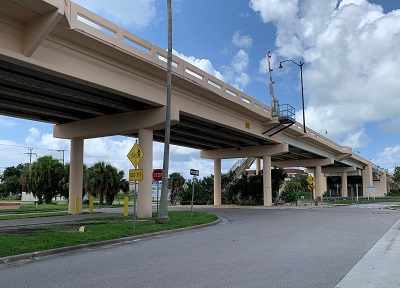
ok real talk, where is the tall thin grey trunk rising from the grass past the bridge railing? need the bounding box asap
[157,0,172,223]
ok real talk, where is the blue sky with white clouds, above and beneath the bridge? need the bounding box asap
[0,0,400,179]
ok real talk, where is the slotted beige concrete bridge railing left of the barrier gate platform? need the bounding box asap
[64,0,271,119]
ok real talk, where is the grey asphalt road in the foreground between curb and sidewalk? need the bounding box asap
[0,207,400,288]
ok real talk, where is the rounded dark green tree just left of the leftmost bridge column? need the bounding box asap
[22,156,65,204]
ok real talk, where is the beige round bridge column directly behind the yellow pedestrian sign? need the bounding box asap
[137,129,153,218]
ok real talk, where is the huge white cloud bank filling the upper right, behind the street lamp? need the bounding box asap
[250,0,400,140]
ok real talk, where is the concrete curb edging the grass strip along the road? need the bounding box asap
[0,217,223,269]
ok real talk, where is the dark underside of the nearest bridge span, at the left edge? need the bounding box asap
[0,61,153,124]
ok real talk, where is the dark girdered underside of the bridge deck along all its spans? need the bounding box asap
[0,61,354,166]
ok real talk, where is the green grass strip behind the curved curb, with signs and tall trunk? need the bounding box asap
[0,211,218,257]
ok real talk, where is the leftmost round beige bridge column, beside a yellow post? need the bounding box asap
[68,138,84,214]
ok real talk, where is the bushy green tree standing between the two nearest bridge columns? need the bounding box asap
[84,161,124,205]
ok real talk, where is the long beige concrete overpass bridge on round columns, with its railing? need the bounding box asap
[0,0,387,217]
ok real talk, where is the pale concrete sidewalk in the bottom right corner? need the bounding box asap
[335,219,400,288]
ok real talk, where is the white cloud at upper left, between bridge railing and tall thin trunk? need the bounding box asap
[74,0,157,28]
